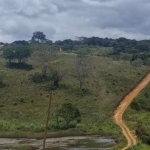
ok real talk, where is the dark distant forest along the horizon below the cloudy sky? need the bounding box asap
[0,35,150,65]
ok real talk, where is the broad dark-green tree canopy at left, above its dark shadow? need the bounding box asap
[2,46,32,63]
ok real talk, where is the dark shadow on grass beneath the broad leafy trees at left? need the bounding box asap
[6,62,33,71]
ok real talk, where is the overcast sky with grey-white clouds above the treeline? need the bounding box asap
[0,0,150,43]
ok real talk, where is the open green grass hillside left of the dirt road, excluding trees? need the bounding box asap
[0,45,149,148]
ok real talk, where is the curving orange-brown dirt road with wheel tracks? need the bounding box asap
[113,72,150,150]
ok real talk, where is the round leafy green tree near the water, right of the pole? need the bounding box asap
[59,103,81,127]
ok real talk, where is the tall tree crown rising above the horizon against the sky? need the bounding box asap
[31,31,46,43]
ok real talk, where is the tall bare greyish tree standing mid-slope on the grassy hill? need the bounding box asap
[75,51,89,90]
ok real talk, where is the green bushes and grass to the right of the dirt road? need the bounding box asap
[125,84,150,150]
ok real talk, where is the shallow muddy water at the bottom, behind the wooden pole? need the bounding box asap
[0,136,116,150]
